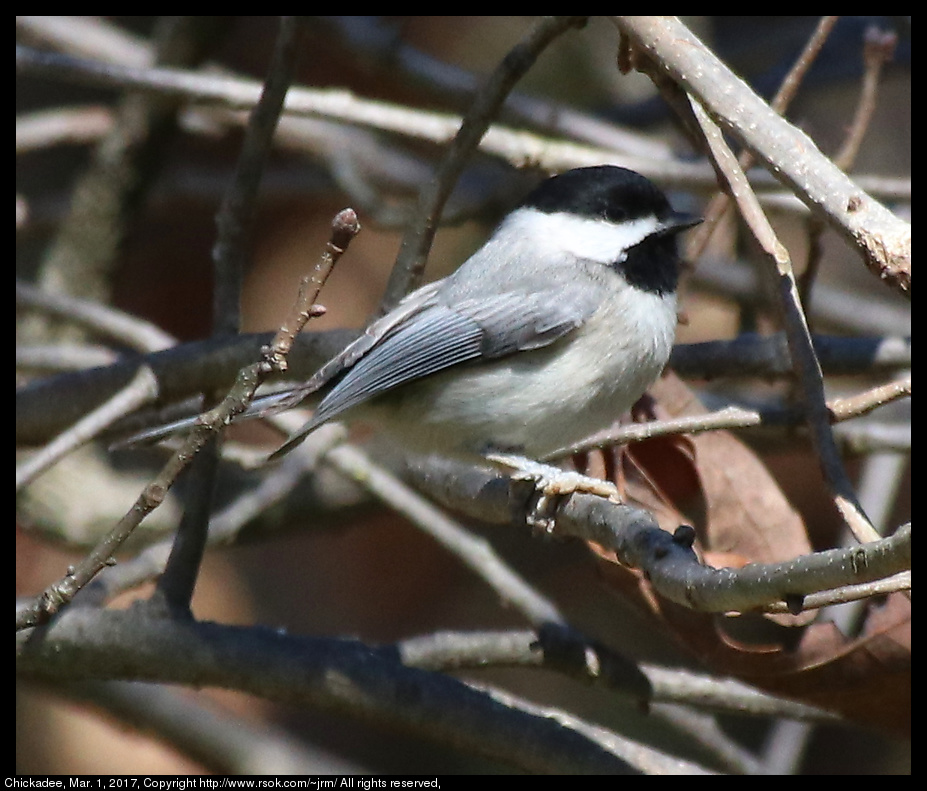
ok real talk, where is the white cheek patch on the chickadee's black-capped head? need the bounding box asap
[506,208,662,264]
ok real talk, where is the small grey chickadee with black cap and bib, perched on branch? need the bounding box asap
[141,165,700,474]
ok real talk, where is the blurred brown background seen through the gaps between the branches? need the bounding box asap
[16,16,911,774]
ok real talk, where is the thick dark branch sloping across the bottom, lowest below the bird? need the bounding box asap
[17,608,644,774]
